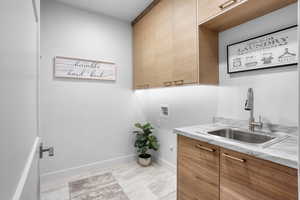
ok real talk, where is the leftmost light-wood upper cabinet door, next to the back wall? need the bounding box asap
[133,0,173,89]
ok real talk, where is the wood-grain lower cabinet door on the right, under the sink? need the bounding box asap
[220,149,298,200]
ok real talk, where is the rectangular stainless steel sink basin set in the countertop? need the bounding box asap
[208,128,276,144]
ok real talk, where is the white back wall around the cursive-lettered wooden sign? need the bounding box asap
[40,0,144,174]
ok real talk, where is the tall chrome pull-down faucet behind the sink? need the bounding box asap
[245,88,263,132]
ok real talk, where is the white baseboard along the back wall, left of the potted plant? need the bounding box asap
[41,154,135,183]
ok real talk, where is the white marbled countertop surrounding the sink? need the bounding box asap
[174,123,298,169]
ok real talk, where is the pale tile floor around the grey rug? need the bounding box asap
[41,162,176,200]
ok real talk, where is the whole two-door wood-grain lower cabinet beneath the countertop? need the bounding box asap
[177,136,298,200]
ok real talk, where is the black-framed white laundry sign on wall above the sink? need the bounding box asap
[227,25,298,74]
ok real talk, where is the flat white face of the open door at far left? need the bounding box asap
[0,0,37,200]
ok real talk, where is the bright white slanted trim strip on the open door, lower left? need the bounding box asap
[12,137,40,200]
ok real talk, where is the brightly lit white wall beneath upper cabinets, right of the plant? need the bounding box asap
[136,85,218,165]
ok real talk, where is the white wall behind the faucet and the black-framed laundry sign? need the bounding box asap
[217,3,298,126]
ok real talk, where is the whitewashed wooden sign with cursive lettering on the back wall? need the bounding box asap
[54,56,117,81]
